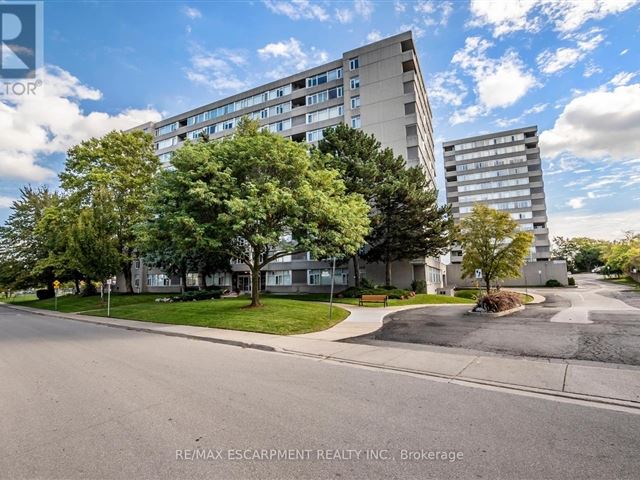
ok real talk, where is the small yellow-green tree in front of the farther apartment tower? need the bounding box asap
[459,204,533,293]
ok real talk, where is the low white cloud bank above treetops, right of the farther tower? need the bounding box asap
[549,209,640,240]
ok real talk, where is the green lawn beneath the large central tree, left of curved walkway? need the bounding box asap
[10,294,349,335]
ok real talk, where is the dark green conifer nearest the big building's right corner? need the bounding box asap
[365,149,454,285]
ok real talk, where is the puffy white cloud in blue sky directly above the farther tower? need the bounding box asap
[451,37,538,124]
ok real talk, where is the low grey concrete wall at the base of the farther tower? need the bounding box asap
[447,260,568,287]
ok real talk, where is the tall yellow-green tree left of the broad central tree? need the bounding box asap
[60,131,159,293]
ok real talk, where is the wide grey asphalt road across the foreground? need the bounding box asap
[0,306,640,479]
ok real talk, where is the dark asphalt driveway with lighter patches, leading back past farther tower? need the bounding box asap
[352,274,640,365]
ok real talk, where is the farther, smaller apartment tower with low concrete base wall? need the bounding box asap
[443,126,567,286]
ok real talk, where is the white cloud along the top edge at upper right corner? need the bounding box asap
[469,0,639,37]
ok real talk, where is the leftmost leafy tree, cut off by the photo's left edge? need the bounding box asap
[0,186,60,290]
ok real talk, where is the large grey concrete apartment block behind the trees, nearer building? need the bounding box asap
[124,32,443,292]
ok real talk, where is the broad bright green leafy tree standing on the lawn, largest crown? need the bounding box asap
[162,119,369,307]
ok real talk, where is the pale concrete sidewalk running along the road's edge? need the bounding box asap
[8,305,640,410]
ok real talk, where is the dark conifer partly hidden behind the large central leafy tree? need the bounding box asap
[318,123,382,287]
